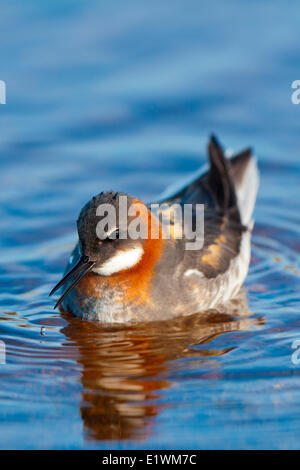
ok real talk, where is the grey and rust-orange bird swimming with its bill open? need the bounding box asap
[49,135,259,324]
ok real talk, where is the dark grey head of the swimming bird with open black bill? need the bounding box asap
[50,192,159,307]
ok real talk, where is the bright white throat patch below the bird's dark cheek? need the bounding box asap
[93,246,144,276]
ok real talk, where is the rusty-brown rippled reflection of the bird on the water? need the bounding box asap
[62,295,262,441]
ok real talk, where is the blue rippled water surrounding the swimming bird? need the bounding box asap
[0,0,300,449]
